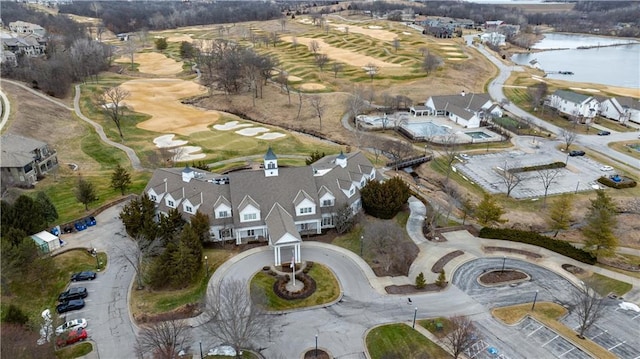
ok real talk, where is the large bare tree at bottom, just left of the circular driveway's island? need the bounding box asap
[203,279,272,358]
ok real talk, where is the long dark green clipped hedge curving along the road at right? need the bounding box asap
[479,227,597,264]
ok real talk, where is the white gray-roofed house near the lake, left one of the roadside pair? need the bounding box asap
[547,90,600,124]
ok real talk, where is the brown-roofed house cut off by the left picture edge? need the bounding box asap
[0,134,58,187]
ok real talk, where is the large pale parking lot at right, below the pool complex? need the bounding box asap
[454,137,615,199]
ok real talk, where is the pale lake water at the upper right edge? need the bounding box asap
[511,33,640,88]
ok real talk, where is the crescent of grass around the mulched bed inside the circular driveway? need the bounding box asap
[251,263,340,310]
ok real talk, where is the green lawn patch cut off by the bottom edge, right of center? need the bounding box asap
[366,324,452,359]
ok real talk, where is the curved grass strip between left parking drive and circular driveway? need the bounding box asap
[130,249,234,318]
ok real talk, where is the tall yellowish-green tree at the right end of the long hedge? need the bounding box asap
[582,190,618,257]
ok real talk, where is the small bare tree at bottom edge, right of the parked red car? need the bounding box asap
[136,320,191,359]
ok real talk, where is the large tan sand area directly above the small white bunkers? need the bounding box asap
[120,79,220,136]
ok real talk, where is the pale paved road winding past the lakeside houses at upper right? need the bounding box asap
[465,37,640,170]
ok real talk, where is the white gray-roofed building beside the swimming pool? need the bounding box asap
[425,91,503,128]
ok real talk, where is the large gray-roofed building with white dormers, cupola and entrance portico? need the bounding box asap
[144,148,378,265]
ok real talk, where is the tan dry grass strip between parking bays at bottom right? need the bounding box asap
[491,302,616,359]
